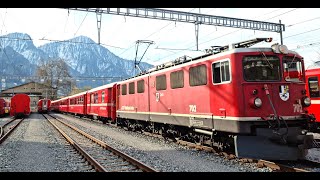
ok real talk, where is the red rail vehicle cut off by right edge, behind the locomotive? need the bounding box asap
[306,67,320,132]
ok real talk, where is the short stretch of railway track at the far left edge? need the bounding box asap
[0,118,24,144]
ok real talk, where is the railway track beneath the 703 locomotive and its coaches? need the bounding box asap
[55,113,320,172]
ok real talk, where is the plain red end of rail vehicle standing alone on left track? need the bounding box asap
[10,94,30,118]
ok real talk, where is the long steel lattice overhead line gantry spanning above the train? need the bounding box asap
[64,8,285,47]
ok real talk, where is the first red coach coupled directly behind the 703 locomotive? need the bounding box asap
[87,83,117,123]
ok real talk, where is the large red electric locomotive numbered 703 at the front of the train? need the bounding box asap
[116,38,313,160]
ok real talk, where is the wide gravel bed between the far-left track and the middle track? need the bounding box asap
[0,113,92,172]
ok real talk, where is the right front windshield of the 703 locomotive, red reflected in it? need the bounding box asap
[283,56,303,82]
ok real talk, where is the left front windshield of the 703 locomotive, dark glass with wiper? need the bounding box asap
[243,55,280,81]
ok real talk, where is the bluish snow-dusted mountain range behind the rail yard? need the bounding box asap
[0,32,153,88]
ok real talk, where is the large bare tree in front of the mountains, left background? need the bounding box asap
[36,58,76,99]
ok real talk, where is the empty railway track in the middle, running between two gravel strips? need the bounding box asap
[43,114,157,172]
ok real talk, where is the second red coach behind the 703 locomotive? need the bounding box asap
[68,92,87,116]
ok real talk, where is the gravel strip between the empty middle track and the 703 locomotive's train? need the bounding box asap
[56,114,270,172]
